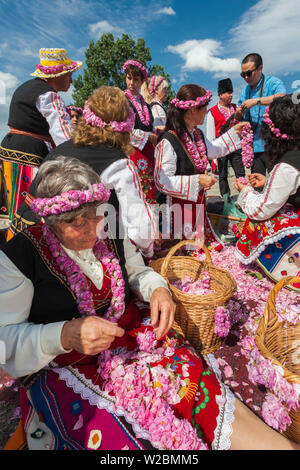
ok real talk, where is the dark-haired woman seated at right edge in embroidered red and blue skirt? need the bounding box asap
[235,95,300,290]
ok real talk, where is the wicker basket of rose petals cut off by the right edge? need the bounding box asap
[255,276,300,443]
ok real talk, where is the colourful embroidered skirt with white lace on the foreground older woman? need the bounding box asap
[21,306,235,450]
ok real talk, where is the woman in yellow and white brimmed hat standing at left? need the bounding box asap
[0,48,82,237]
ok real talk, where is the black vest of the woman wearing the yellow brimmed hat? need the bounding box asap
[8,78,55,135]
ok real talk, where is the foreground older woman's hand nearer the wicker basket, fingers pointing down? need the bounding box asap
[150,287,176,339]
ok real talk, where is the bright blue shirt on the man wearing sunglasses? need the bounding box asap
[238,76,286,152]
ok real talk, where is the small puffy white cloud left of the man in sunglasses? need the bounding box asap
[167,39,240,76]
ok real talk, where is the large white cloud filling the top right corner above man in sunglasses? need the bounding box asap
[228,0,300,74]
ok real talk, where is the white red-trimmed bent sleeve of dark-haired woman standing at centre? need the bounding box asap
[154,139,200,201]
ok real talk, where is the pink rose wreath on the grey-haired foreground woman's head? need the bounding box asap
[30,183,110,217]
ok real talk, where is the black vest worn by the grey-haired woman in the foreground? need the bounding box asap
[2,227,129,324]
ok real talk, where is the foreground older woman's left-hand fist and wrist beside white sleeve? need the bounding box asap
[61,316,125,356]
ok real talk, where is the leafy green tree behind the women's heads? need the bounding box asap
[72,33,175,107]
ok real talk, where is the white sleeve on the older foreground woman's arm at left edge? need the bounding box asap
[0,251,67,377]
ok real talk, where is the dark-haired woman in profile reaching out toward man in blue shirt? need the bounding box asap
[154,84,245,249]
